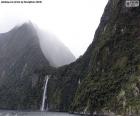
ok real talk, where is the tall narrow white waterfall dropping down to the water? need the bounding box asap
[40,75,49,111]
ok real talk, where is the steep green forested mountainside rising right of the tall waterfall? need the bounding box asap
[47,0,140,115]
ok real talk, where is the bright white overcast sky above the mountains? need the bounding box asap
[0,0,108,57]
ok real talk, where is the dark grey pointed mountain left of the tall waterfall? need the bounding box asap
[0,24,49,109]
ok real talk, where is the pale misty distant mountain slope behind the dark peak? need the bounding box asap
[37,29,76,67]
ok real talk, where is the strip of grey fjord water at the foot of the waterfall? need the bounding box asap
[0,111,78,116]
